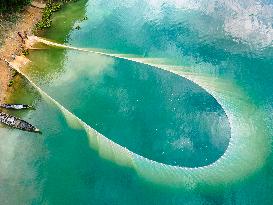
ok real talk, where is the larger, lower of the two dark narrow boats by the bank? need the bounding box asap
[0,112,41,133]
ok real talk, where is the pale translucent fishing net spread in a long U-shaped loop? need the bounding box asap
[9,36,270,189]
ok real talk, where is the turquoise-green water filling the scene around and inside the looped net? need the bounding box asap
[0,0,273,204]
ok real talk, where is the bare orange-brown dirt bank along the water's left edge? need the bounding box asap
[0,4,43,103]
